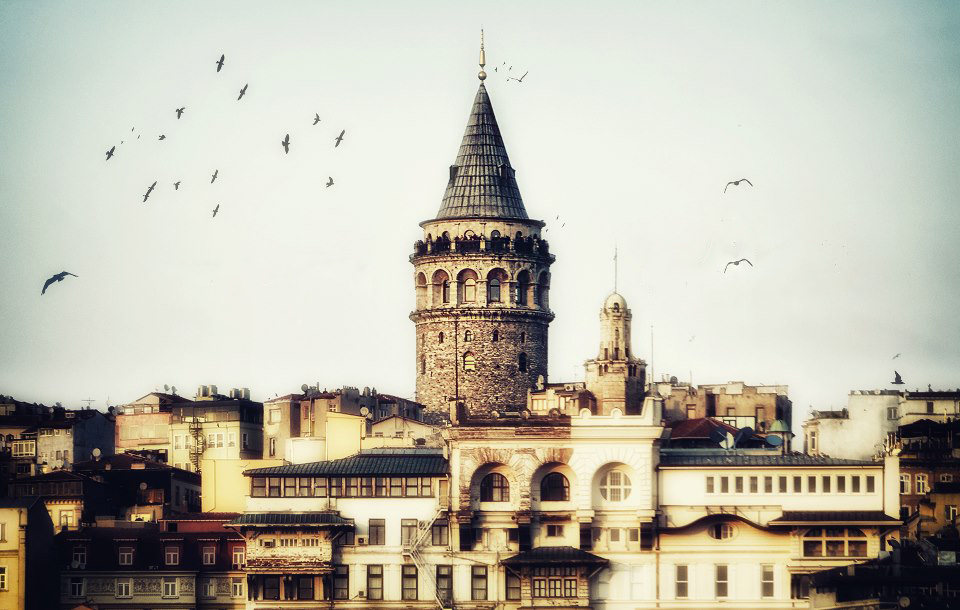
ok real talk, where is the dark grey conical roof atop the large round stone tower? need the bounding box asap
[437,83,527,219]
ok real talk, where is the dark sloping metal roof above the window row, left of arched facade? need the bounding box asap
[244,450,449,477]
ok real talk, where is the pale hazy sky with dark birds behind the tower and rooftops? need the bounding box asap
[0,0,960,431]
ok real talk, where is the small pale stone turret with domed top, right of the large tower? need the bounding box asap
[584,292,647,415]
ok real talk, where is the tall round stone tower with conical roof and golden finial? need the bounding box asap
[410,48,554,417]
